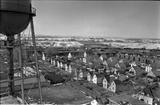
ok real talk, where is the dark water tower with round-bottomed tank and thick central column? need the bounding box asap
[0,0,42,102]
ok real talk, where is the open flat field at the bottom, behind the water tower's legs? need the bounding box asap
[26,85,92,104]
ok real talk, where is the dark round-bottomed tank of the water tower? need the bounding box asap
[0,0,33,36]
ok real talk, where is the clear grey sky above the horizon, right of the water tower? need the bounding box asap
[32,0,160,38]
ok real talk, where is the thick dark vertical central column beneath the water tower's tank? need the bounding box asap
[7,35,14,96]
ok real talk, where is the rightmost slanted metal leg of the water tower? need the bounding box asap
[31,17,42,104]
